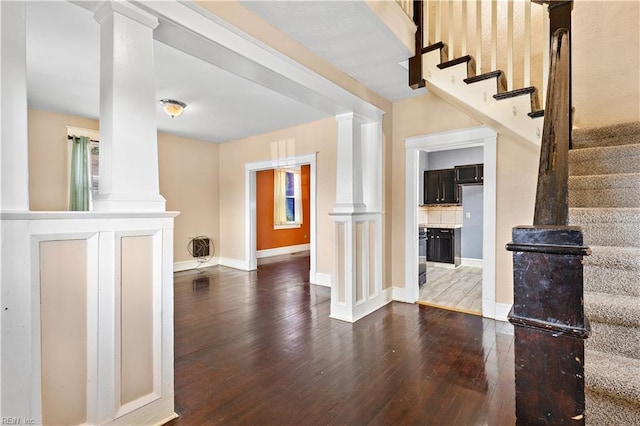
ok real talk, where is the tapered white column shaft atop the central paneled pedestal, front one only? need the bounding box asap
[333,112,365,213]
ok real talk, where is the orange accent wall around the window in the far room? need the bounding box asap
[256,165,311,250]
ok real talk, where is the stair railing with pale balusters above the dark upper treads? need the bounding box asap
[410,0,550,107]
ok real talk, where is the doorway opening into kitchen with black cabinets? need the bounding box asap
[417,146,484,315]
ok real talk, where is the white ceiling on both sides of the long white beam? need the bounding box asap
[27,1,415,142]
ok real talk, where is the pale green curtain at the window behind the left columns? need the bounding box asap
[69,136,91,211]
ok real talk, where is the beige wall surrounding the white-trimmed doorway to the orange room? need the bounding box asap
[220,117,337,273]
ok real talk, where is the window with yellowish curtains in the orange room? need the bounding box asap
[273,169,302,229]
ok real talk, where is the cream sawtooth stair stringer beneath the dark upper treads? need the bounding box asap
[422,49,544,146]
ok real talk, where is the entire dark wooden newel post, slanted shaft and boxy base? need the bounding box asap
[507,1,589,425]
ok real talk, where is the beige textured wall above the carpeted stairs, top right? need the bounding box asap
[571,0,640,127]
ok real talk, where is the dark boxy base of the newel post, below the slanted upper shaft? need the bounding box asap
[507,226,589,425]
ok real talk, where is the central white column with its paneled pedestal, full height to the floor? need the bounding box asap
[331,113,384,322]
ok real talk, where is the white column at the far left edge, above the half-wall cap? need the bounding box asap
[0,1,29,211]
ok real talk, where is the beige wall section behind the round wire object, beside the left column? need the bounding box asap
[158,133,220,262]
